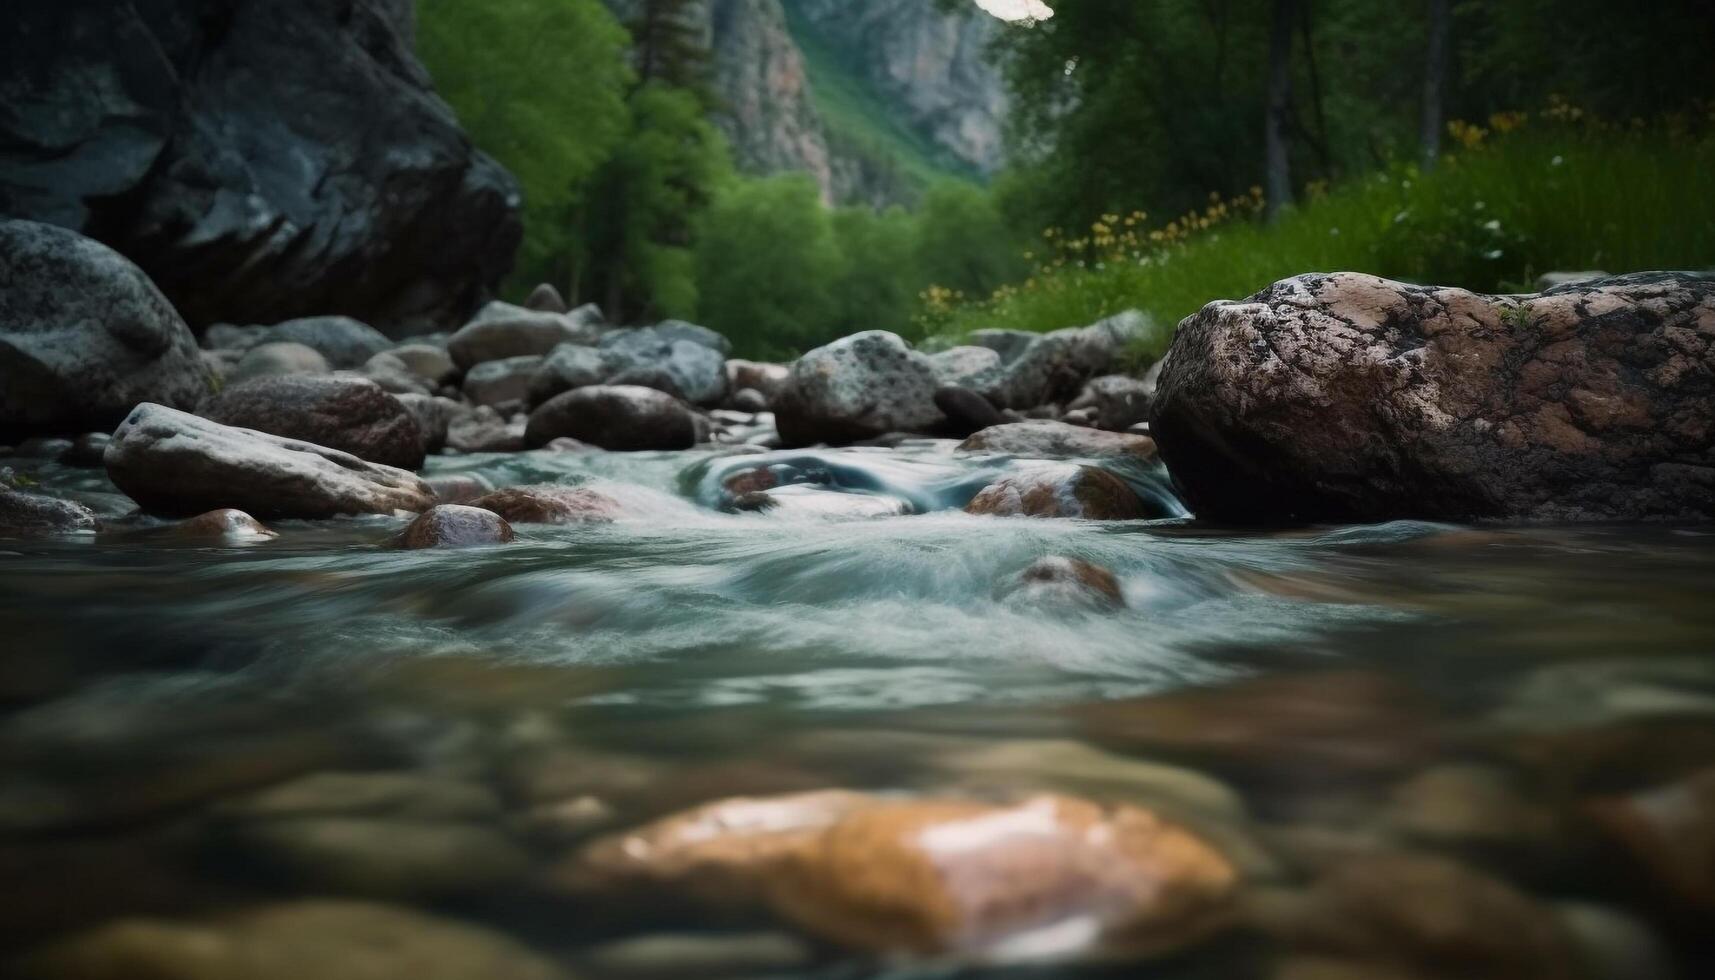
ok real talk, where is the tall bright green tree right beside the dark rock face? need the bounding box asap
[417,0,635,285]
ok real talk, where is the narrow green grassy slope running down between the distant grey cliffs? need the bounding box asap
[784,3,974,196]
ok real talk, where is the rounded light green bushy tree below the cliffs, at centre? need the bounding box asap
[695,173,840,357]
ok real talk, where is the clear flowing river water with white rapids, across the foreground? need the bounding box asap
[0,441,1715,978]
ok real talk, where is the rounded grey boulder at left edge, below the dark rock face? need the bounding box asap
[0,224,211,438]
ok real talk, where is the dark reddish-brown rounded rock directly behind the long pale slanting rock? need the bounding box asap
[197,374,424,470]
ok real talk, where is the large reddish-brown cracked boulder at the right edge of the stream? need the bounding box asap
[1151,273,1715,522]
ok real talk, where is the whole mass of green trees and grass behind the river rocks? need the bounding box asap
[418,0,1715,359]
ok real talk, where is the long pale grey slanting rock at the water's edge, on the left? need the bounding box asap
[106,403,434,517]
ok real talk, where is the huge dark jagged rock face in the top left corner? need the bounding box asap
[0,0,520,335]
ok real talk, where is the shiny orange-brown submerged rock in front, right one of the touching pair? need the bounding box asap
[770,796,1238,961]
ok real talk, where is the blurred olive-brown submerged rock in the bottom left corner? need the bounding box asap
[14,898,561,980]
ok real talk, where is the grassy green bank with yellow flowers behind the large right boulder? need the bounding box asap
[924,129,1715,360]
